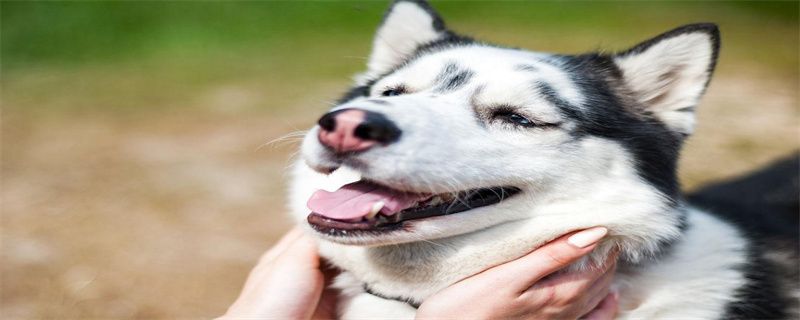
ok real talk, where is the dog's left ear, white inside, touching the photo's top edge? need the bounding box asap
[367,0,447,76]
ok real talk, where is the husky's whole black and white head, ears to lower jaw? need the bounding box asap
[294,1,718,245]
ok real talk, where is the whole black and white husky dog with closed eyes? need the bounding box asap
[291,1,796,319]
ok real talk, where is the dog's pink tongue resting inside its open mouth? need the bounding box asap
[307,182,427,220]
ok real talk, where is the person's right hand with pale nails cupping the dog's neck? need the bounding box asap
[417,227,618,320]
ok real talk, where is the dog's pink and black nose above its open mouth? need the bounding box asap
[317,108,402,144]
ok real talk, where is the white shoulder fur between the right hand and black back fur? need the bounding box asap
[616,210,747,319]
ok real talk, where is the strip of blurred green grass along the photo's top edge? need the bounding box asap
[2,1,798,69]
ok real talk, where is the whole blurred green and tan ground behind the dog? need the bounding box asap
[0,1,800,319]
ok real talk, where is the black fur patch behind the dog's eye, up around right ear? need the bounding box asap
[539,23,720,203]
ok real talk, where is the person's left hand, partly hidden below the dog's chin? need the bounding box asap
[219,227,336,319]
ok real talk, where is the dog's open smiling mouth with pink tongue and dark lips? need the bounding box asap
[308,181,520,236]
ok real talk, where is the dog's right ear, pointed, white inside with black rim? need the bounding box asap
[614,23,719,135]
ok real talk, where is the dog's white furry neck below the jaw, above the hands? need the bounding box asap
[324,195,686,302]
